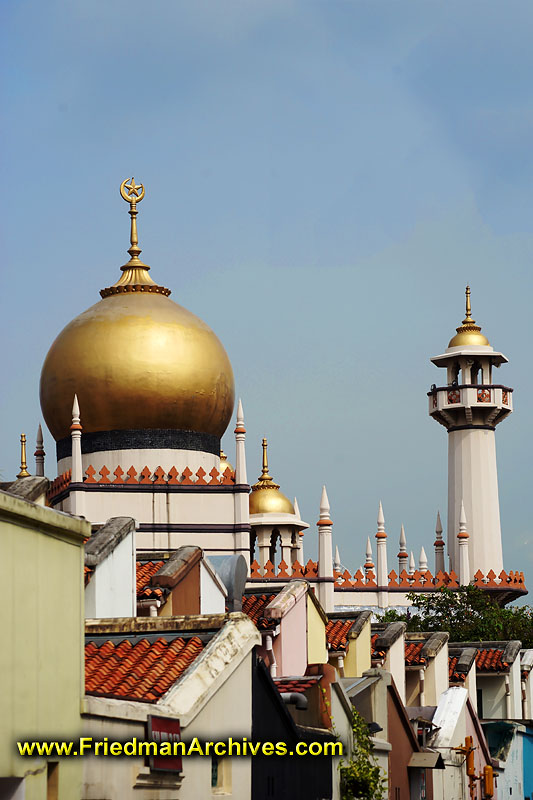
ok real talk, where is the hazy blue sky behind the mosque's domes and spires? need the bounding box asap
[0,0,533,587]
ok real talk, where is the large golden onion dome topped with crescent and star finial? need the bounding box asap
[40,179,235,440]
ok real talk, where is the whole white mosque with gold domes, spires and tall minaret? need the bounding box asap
[35,178,526,612]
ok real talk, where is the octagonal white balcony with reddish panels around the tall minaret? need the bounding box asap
[428,383,513,428]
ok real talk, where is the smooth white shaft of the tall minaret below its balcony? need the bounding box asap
[448,429,503,575]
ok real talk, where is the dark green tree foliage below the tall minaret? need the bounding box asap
[381,586,533,647]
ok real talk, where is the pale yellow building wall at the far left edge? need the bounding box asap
[0,492,90,800]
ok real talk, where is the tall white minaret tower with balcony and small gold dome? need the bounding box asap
[428,286,513,577]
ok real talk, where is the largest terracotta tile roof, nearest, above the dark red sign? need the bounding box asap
[85,636,204,703]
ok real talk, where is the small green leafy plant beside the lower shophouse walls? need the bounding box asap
[339,708,386,800]
